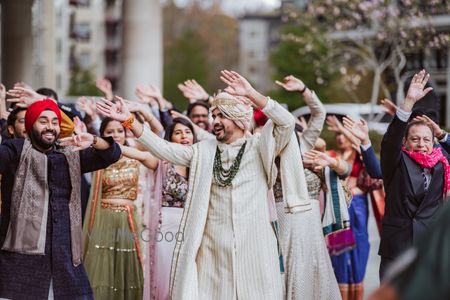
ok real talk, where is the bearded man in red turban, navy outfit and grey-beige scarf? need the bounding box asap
[0,99,121,299]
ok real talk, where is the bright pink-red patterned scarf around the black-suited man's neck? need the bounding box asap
[402,147,450,197]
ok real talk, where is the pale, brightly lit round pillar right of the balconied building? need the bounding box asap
[119,0,163,98]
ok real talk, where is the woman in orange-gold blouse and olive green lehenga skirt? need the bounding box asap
[83,118,143,300]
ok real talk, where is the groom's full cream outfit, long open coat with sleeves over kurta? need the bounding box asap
[139,101,295,300]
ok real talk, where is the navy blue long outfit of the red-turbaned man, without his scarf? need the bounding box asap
[0,139,121,299]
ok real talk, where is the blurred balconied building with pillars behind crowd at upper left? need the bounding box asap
[0,0,162,97]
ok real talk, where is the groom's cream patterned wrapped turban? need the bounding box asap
[209,92,253,131]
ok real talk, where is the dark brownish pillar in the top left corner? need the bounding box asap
[2,0,33,88]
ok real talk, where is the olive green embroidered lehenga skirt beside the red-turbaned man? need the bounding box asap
[84,204,143,300]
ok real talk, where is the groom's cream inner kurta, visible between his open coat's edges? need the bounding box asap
[197,137,281,299]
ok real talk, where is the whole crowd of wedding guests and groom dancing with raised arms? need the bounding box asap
[0,70,450,300]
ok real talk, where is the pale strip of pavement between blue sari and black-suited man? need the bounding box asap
[364,199,380,299]
